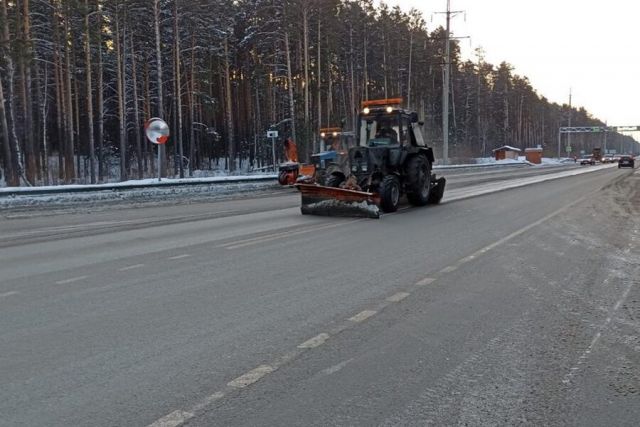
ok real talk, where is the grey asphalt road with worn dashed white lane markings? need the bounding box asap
[0,168,640,426]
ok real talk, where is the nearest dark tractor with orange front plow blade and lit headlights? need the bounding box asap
[296,98,446,218]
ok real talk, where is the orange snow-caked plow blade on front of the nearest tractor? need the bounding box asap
[296,184,380,219]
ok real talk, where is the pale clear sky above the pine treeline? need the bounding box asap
[386,0,640,126]
